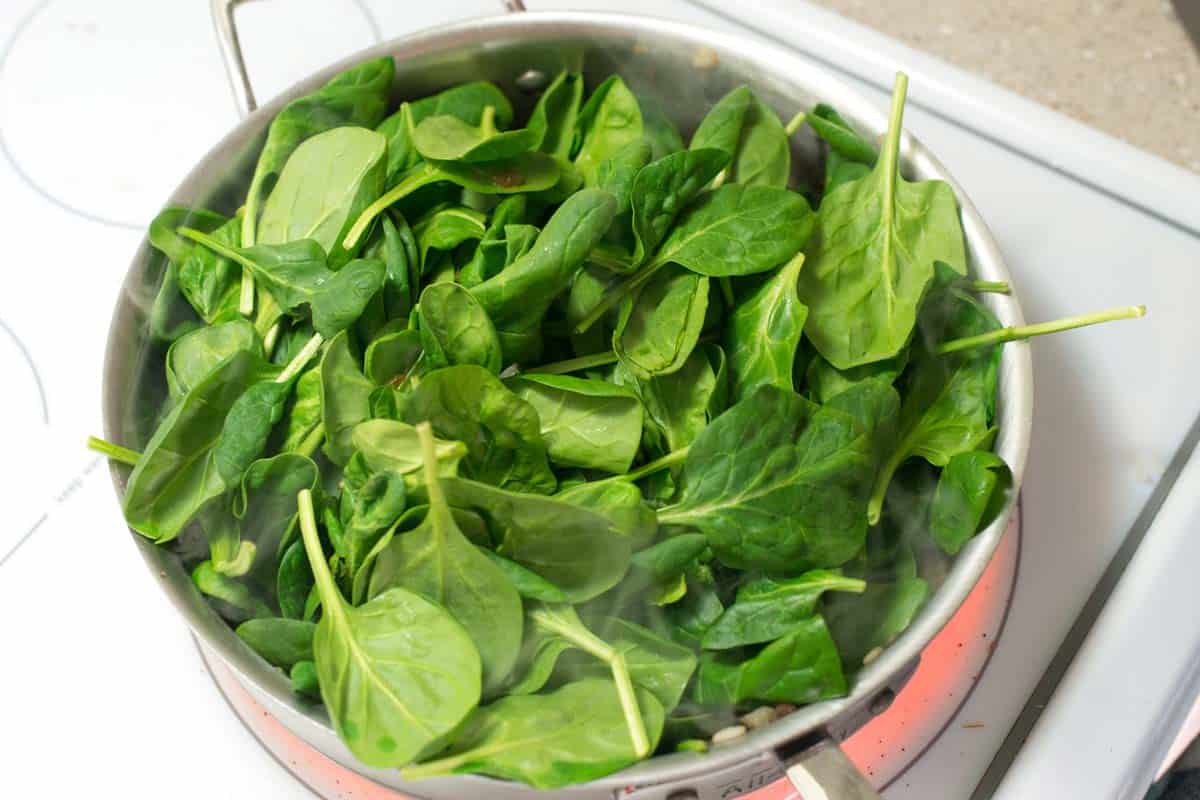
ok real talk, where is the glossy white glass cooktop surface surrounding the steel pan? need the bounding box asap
[0,0,1200,800]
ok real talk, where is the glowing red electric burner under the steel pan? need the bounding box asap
[199,504,1021,800]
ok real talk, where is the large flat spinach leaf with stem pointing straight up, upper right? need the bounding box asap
[799,74,966,369]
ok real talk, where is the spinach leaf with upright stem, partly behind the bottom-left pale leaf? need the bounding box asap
[368,423,522,694]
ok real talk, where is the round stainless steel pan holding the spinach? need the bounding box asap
[104,0,1033,800]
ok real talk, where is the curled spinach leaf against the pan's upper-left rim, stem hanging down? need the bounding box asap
[241,58,396,246]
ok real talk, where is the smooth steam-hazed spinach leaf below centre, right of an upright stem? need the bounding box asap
[442,477,632,603]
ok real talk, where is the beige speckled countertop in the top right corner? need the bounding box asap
[816,0,1200,172]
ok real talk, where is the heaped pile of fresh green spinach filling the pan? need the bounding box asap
[92,59,1140,788]
